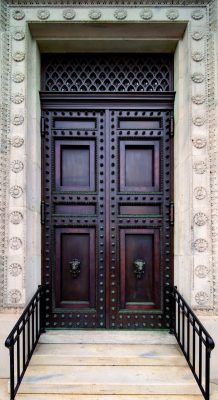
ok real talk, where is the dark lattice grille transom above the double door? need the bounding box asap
[42,54,173,92]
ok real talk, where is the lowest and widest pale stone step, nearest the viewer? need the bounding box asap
[19,365,200,399]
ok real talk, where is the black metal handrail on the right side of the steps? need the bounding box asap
[171,287,215,400]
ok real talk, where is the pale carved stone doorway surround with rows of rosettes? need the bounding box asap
[0,0,218,377]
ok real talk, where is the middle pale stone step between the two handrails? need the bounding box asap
[31,343,187,366]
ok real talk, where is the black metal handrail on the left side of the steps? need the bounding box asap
[5,286,45,400]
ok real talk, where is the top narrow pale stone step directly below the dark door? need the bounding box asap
[39,330,177,344]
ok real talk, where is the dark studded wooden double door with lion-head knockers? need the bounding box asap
[41,93,173,329]
